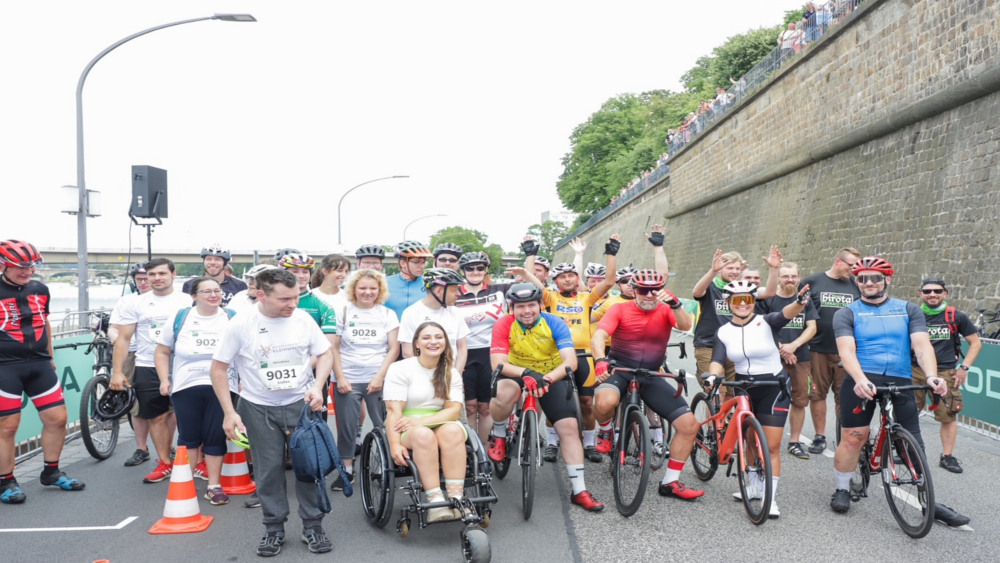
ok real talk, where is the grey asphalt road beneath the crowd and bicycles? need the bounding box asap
[0,332,1000,563]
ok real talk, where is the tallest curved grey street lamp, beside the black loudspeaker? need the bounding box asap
[76,14,257,311]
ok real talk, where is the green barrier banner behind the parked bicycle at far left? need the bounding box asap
[14,334,94,443]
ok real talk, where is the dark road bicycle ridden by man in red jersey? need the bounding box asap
[608,363,687,517]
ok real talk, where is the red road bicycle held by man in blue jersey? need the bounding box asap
[850,385,948,538]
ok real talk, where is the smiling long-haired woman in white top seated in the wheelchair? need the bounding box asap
[382,322,468,522]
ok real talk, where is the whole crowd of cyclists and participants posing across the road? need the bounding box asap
[0,230,981,556]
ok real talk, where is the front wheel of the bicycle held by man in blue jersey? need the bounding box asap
[881,427,934,538]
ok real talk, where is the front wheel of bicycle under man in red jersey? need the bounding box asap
[610,408,649,517]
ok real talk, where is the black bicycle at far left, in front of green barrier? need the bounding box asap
[53,313,122,460]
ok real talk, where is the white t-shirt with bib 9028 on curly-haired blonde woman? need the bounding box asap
[337,303,399,383]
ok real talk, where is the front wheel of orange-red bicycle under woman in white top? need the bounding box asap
[737,416,774,526]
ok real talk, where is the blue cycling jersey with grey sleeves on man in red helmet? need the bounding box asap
[833,298,927,379]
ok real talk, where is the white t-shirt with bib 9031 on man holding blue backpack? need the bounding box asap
[212,309,330,406]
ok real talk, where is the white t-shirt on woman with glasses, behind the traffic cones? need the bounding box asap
[157,308,232,393]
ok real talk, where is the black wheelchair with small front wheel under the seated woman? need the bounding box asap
[360,425,497,563]
